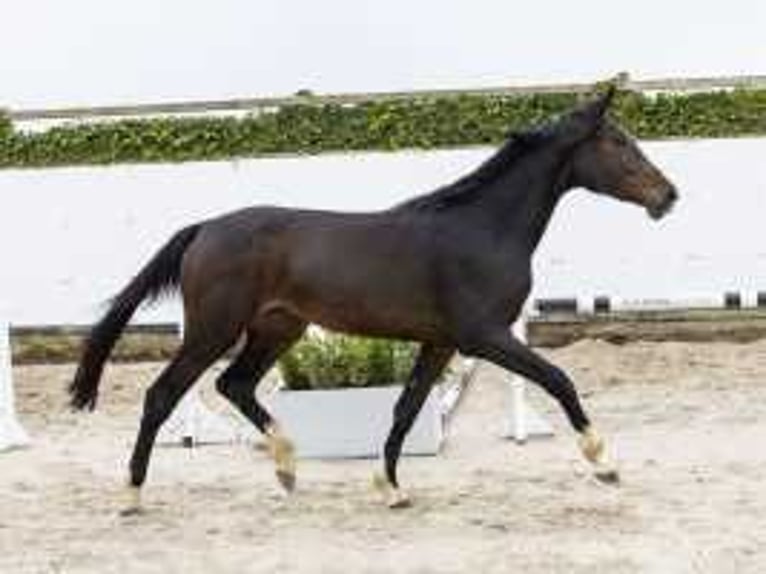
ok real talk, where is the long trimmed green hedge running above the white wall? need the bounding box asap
[0,90,766,168]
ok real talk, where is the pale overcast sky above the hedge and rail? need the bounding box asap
[0,0,766,109]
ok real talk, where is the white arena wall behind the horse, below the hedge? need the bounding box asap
[0,138,766,324]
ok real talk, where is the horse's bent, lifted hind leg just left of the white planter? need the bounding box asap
[216,315,306,492]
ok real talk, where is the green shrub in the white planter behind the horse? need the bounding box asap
[278,334,417,390]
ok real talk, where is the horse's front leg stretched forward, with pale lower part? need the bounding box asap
[458,326,619,483]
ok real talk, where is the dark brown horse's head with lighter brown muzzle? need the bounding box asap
[562,90,678,219]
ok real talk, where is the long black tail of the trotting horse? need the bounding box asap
[69,225,200,410]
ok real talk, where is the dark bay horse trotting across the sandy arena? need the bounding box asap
[70,90,677,510]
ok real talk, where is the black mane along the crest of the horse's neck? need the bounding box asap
[394,126,553,214]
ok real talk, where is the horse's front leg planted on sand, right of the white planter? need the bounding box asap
[374,344,455,508]
